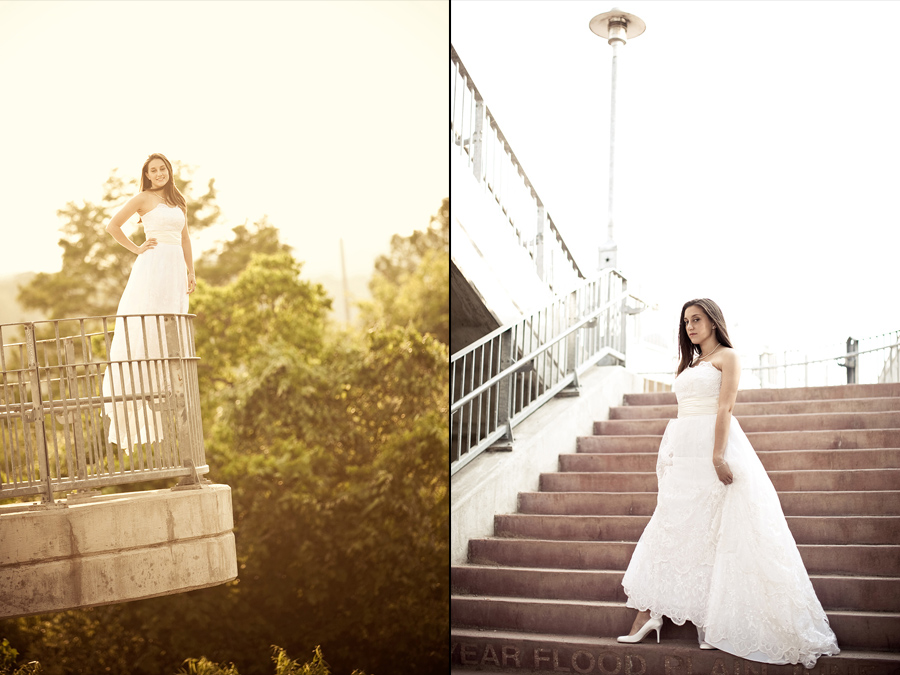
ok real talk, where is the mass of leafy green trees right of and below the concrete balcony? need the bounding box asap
[0,184,449,675]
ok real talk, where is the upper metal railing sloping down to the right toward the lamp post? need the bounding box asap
[450,45,585,289]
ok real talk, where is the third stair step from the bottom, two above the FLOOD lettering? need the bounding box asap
[450,565,900,612]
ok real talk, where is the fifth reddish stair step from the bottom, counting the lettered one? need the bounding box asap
[494,513,900,544]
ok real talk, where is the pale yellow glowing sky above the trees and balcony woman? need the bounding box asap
[0,0,449,276]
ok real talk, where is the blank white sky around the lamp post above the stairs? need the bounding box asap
[450,0,900,350]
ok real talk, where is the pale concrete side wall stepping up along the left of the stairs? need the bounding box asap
[450,366,644,565]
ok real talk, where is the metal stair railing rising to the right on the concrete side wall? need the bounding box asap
[450,270,630,475]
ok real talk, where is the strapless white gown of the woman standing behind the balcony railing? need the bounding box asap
[103,204,188,452]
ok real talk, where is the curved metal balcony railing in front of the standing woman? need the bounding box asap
[0,314,209,504]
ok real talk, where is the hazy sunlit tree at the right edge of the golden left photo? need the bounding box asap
[360,198,450,344]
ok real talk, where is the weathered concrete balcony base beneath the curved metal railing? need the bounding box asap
[0,485,237,617]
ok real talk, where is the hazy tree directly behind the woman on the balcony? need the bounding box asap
[18,165,221,319]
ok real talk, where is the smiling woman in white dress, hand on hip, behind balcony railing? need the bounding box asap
[102,153,196,452]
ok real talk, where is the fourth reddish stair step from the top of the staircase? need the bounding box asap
[575,429,900,452]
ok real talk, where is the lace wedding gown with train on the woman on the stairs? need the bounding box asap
[622,361,839,668]
